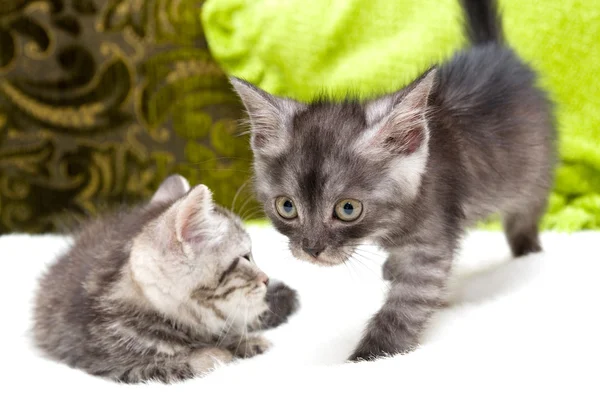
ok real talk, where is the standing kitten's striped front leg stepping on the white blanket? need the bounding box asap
[350,245,452,361]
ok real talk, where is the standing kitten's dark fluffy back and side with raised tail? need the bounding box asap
[430,0,556,224]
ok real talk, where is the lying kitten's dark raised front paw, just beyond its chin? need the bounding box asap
[260,282,300,329]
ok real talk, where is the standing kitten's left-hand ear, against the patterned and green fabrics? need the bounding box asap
[230,77,305,155]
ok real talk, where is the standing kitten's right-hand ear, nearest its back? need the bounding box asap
[366,69,436,155]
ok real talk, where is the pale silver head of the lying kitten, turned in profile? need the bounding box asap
[130,176,268,334]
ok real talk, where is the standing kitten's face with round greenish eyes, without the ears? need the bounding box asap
[256,104,396,265]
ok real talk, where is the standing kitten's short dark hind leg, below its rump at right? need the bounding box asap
[503,202,545,257]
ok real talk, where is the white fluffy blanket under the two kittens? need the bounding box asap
[0,227,600,398]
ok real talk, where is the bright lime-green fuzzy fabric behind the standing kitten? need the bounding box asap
[202,0,600,231]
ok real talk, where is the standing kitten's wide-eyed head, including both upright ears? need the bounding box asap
[231,70,435,265]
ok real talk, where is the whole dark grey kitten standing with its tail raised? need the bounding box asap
[232,0,556,360]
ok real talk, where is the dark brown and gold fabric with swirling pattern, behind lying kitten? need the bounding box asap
[0,0,255,233]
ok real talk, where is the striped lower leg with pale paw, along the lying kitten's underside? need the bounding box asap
[111,347,233,384]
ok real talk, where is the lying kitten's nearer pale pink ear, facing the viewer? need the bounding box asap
[175,184,213,243]
